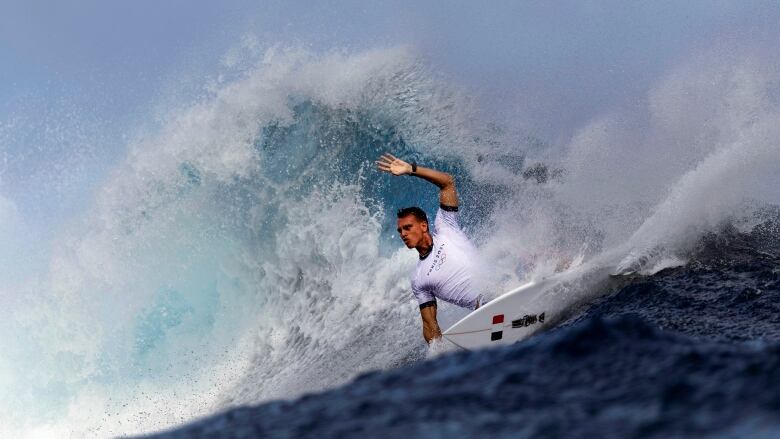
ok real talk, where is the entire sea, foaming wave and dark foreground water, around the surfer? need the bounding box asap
[0,48,780,437]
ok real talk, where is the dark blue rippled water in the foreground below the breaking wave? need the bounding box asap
[146,222,780,438]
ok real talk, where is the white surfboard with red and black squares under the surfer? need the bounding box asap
[442,269,609,349]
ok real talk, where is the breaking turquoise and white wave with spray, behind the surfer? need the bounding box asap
[0,43,780,437]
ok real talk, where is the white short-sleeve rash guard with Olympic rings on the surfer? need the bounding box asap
[412,205,482,309]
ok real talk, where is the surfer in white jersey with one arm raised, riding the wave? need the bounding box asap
[376,153,483,343]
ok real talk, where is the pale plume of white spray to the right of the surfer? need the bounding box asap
[483,45,780,285]
